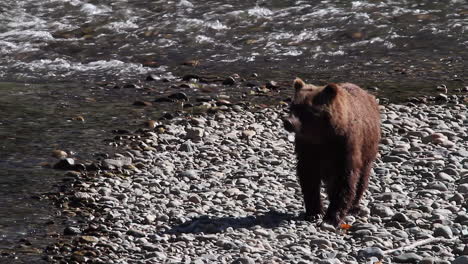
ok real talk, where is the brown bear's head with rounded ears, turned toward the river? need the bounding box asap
[283,78,340,143]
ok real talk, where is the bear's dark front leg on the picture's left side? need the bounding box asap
[297,160,323,221]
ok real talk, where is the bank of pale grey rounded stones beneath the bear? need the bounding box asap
[46,100,468,264]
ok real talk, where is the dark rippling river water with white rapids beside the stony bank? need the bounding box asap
[0,0,468,261]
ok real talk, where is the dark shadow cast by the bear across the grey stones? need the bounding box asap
[164,211,304,234]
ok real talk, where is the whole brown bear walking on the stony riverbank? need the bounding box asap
[284,78,380,226]
